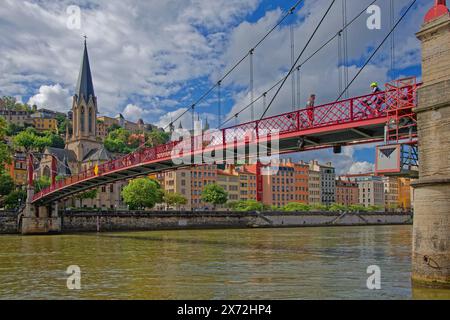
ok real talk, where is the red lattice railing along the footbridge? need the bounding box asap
[34,86,416,201]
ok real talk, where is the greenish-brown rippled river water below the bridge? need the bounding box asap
[0,226,450,299]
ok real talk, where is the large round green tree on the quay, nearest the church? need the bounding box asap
[122,178,164,210]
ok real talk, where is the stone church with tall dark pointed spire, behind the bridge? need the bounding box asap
[38,41,127,210]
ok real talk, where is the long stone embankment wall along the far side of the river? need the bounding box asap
[0,211,412,234]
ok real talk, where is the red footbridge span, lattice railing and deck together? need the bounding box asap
[33,80,417,204]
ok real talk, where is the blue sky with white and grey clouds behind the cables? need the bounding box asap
[0,0,433,172]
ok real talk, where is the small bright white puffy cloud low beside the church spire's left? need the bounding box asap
[28,84,71,112]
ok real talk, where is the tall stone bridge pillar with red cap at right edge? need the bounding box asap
[412,0,450,288]
